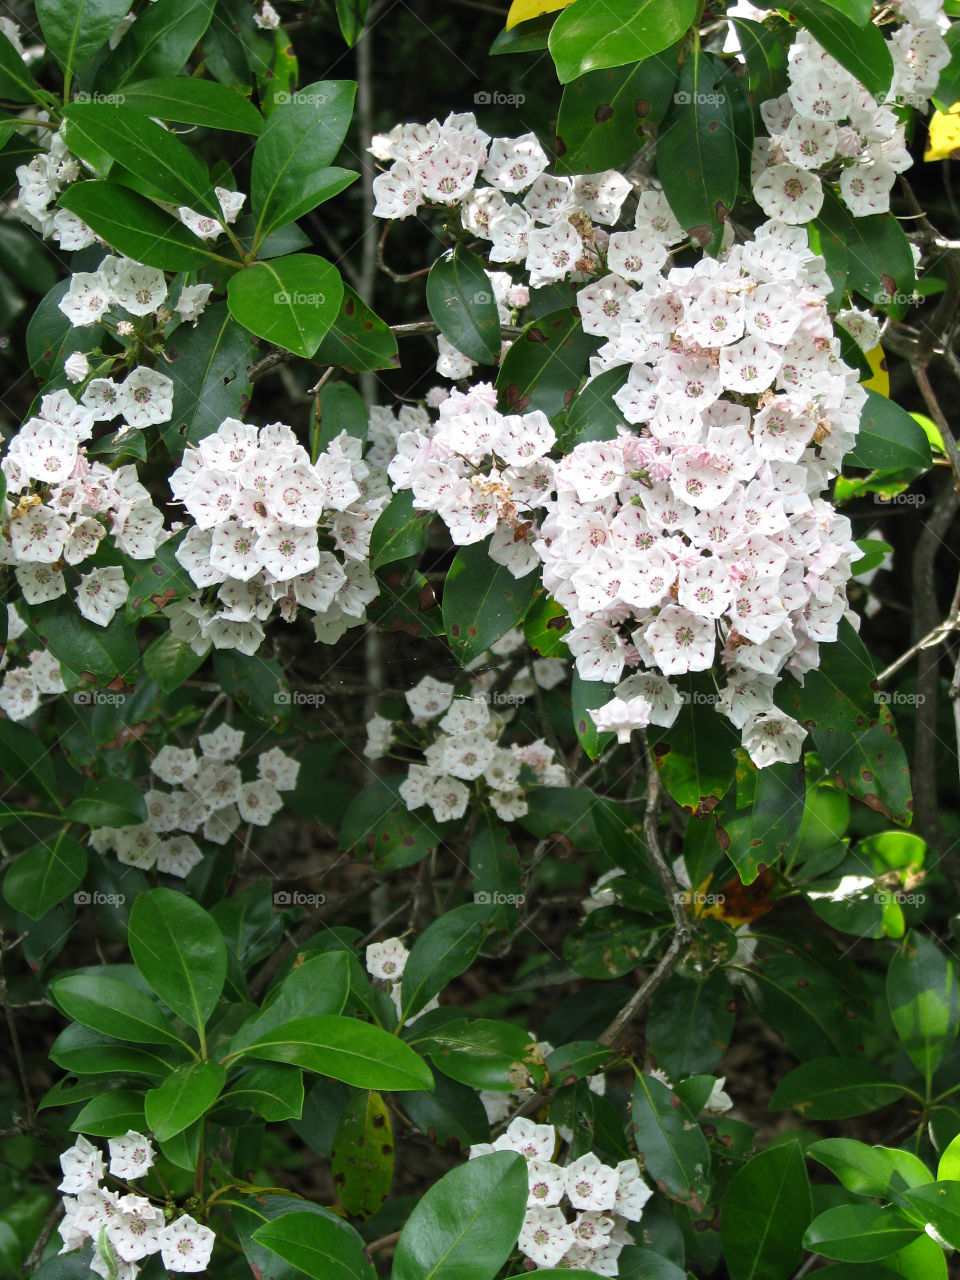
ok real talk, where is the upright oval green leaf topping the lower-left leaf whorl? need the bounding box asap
[128,888,227,1039]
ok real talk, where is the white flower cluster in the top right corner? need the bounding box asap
[753,0,950,224]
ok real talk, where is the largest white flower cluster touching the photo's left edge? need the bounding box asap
[0,384,164,626]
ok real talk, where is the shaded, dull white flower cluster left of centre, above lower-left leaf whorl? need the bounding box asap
[90,724,300,877]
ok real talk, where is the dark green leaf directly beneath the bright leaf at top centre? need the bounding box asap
[557,47,677,174]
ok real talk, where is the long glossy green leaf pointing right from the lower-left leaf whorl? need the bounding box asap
[239,1014,433,1091]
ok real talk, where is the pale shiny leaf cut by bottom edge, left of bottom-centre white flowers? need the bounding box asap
[393,1151,527,1280]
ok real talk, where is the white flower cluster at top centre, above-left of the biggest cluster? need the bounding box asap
[370,113,631,286]
